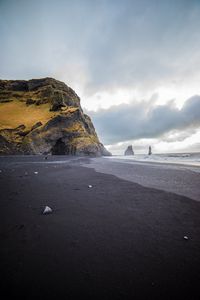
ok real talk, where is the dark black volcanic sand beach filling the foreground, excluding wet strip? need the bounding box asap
[0,157,200,300]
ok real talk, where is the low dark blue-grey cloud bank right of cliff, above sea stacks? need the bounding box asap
[87,95,200,144]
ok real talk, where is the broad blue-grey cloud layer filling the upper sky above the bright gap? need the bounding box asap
[0,0,200,96]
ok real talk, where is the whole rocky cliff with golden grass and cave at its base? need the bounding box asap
[0,78,110,156]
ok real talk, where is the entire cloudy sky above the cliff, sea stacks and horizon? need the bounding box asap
[0,0,200,153]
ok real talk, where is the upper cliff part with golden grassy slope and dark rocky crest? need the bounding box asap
[0,77,81,129]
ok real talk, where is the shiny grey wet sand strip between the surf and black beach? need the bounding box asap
[83,157,200,201]
